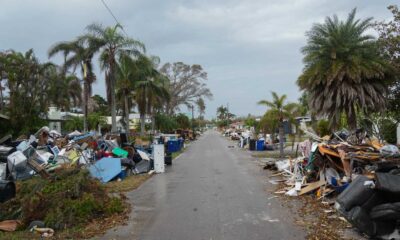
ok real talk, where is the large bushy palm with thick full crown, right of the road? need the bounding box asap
[297,9,388,129]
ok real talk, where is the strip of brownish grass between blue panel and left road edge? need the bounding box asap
[106,173,152,193]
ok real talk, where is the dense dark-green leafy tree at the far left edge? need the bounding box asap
[3,49,56,134]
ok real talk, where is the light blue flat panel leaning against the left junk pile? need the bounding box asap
[89,158,121,183]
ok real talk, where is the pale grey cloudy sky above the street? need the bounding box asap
[0,0,398,118]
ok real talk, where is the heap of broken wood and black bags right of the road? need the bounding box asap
[265,129,400,239]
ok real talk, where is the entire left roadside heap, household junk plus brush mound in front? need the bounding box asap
[0,127,164,237]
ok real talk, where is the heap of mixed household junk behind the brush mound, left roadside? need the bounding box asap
[0,127,159,202]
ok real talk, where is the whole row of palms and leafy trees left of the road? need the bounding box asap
[0,24,212,135]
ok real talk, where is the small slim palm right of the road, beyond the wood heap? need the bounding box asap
[258,92,297,157]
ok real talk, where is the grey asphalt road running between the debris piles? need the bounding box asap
[99,131,305,240]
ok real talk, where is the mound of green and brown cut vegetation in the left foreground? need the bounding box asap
[0,169,126,230]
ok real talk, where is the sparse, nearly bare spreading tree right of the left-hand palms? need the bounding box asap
[160,62,212,114]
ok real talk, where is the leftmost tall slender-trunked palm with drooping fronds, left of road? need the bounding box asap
[48,37,96,131]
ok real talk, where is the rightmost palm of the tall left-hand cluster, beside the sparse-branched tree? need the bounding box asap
[135,55,169,136]
